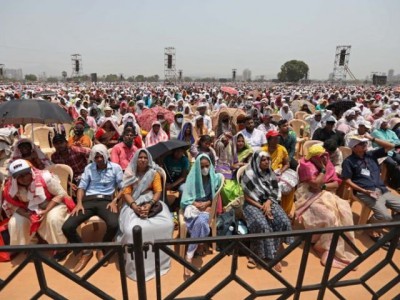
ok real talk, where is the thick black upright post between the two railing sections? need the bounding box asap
[132,225,147,300]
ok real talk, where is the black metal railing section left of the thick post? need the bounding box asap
[0,243,128,299]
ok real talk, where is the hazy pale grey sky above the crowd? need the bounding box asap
[0,0,400,80]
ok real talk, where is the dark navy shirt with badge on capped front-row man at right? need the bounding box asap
[342,148,387,193]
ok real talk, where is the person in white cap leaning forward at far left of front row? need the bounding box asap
[3,159,74,257]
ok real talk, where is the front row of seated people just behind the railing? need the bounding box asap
[3,126,399,278]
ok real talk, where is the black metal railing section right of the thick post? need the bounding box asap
[141,222,400,299]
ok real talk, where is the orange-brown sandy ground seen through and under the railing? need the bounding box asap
[0,203,400,299]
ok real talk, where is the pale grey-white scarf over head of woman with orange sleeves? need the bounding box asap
[122,148,160,205]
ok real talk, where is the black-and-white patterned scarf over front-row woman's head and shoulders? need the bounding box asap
[242,151,280,204]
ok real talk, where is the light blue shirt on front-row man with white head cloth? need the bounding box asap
[79,162,123,196]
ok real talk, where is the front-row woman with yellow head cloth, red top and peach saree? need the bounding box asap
[295,145,354,268]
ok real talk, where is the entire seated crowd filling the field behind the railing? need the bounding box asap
[0,83,400,280]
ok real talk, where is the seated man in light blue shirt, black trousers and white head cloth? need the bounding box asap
[62,144,123,273]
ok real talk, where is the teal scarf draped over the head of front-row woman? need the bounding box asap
[181,153,221,209]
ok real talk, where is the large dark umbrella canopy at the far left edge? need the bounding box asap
[0,99,73,124]
